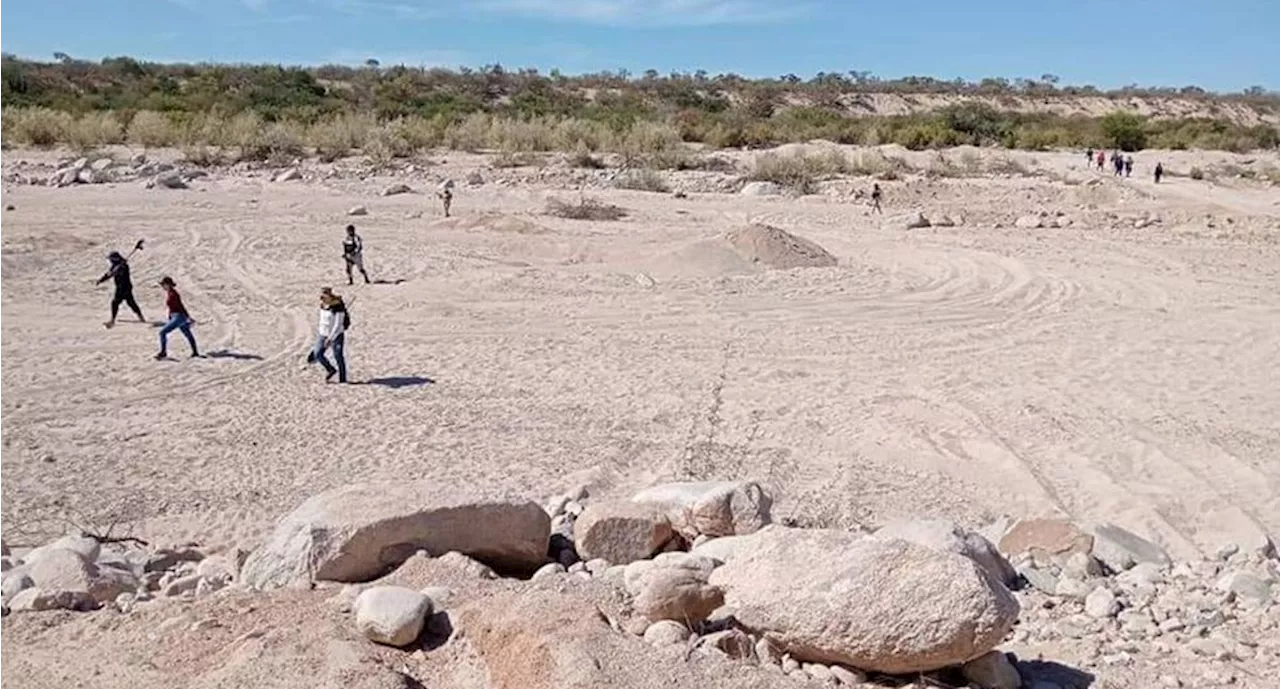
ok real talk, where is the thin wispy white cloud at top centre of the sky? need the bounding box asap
[472,0,800,26]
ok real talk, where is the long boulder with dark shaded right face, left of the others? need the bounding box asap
[241,482,550,589]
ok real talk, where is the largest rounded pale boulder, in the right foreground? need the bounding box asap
[710,526,1019,674]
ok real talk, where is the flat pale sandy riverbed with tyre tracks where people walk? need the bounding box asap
[0,142,1280,566]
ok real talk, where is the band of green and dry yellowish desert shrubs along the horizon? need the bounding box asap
[0,56,1280,156]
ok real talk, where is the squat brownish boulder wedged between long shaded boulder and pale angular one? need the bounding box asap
[576,502,675,565]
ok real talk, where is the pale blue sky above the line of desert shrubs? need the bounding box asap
[0,0,1280,90]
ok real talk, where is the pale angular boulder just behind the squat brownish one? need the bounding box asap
[631,482,773,539]
